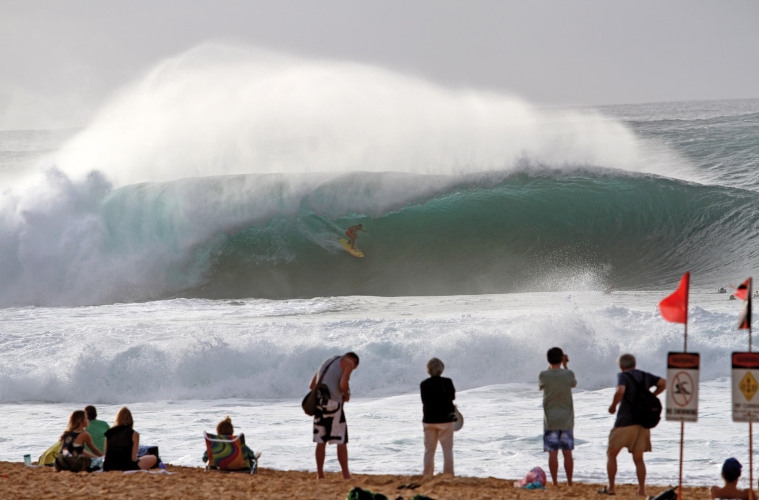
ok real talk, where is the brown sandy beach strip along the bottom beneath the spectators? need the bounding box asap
[0,462,709,500]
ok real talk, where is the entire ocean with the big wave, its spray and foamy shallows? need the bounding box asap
[0,45,759,484]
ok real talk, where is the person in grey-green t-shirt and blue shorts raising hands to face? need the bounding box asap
[538,347,577,486]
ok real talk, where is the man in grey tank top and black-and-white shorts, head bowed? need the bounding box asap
[310,352,359,479]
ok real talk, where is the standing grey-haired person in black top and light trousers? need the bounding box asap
[419,358,456,477]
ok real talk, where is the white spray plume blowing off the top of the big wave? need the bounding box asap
[55,45,685,185]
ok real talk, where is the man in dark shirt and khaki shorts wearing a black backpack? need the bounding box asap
[598,354,667,496]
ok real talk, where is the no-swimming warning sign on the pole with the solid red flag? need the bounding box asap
[666,352,699,422]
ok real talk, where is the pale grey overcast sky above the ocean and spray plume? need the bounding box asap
[0,0,759,130]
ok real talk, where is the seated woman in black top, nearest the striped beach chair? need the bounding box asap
[103,406,158,471]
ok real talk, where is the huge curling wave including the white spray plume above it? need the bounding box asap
[0,45,759,306]
